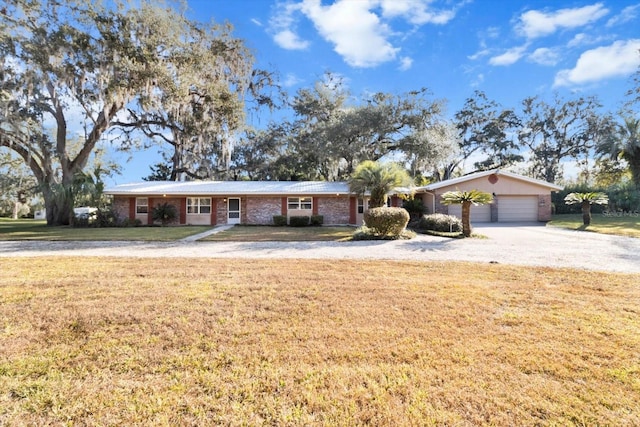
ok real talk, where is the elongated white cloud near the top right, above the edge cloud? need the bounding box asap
[518,3,609,39]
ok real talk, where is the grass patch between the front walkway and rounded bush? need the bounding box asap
[202,225,355,242]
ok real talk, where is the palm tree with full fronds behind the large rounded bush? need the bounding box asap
[349,160,413,208]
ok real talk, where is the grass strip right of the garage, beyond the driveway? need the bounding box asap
[547,214,640,238]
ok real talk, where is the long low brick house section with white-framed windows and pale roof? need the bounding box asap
[105,181,357,225]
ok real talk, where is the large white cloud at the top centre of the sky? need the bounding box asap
[301,0,400,67]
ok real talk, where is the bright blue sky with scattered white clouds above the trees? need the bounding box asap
[107,0,640,183]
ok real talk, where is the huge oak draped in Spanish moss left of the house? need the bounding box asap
[0,0,260,225]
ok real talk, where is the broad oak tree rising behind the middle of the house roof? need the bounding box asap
[236,73,444,181]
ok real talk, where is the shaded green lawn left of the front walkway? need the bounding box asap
[0,218,211,241]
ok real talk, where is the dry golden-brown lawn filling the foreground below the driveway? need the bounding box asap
[0,258,640,426]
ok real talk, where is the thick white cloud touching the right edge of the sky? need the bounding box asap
[554,39,640,87]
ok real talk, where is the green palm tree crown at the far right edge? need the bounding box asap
[597,117,640,189]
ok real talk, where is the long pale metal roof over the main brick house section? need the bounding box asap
[105,181,350,196]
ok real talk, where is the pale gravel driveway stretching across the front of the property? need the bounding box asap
[0,223,640,274]
